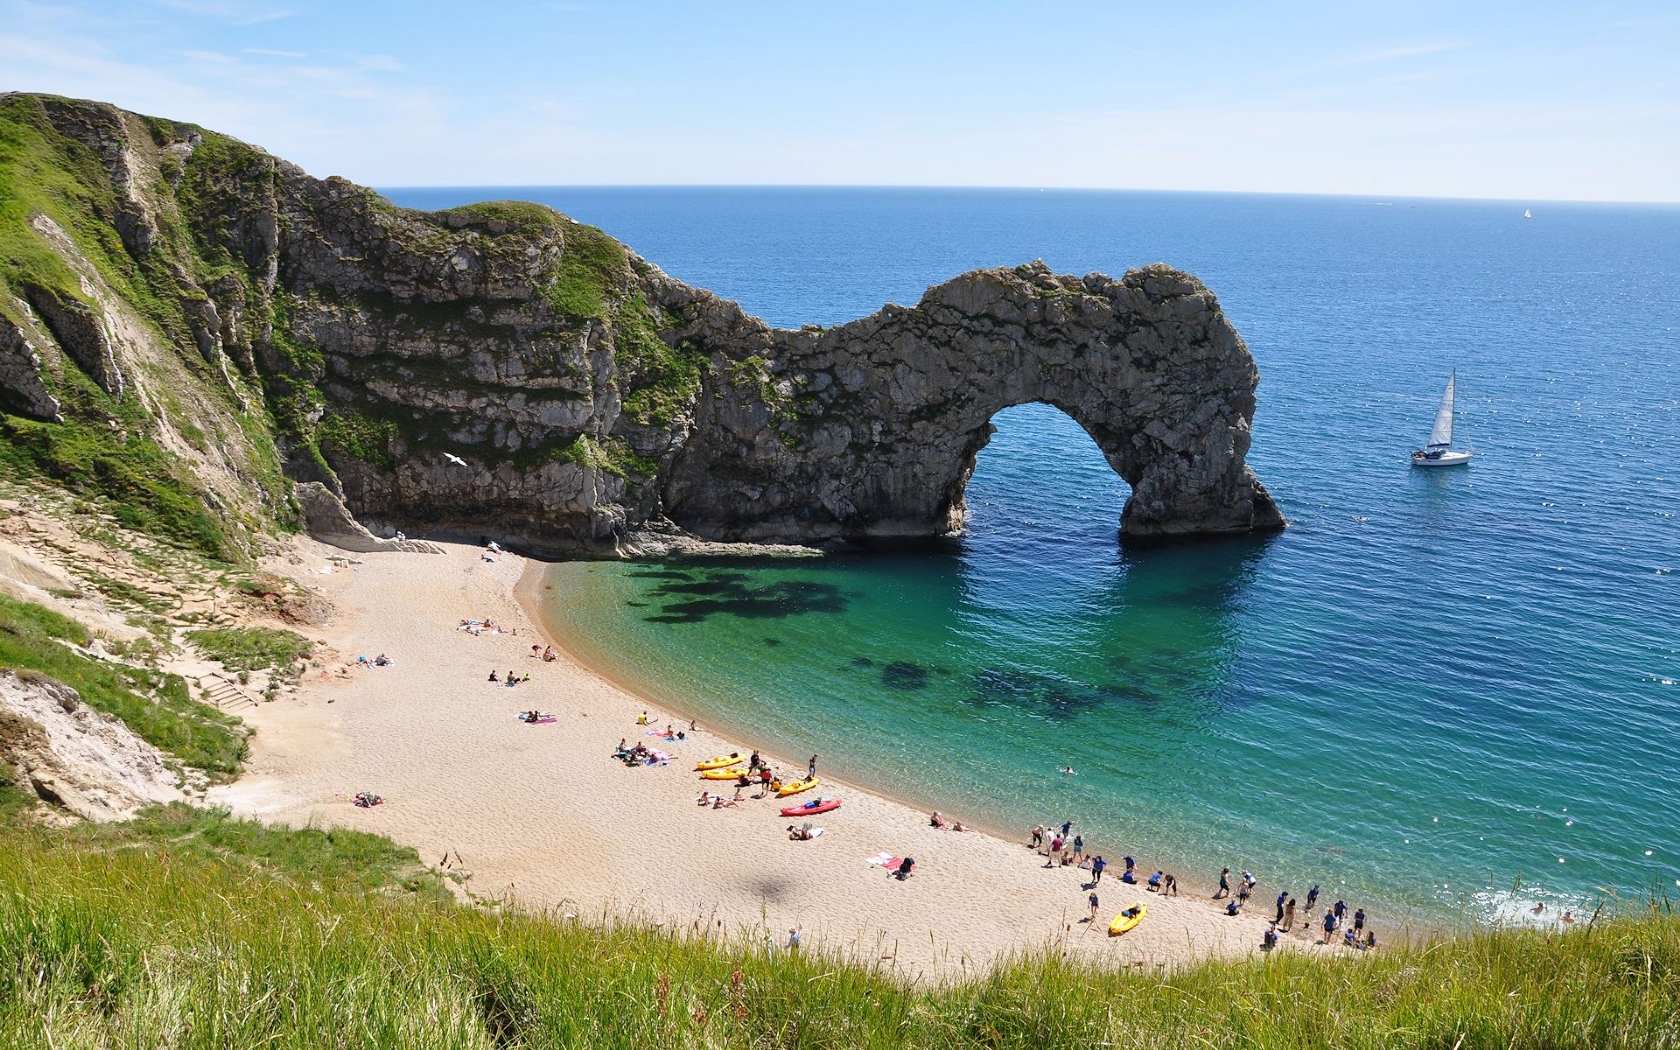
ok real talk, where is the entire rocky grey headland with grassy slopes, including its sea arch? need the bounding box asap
[0,96,1282,551]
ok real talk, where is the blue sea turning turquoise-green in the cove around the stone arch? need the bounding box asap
[388,188,1680,922]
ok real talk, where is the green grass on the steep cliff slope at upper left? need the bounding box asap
[0,94,284,559]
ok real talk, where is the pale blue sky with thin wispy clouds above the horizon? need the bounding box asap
[0,0,1680,202]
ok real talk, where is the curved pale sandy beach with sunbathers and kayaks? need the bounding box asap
[212,539,1312,979]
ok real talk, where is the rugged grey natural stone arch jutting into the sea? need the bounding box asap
[662,264,1284,541]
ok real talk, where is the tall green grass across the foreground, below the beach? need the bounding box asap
[0,810,1680,1050]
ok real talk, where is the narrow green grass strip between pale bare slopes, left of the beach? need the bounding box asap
[0,595,249,778]
